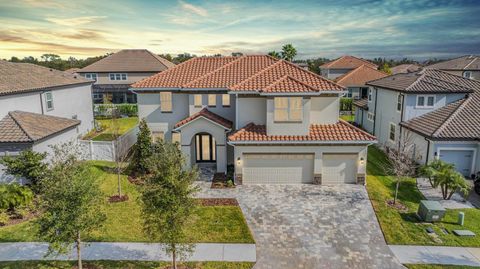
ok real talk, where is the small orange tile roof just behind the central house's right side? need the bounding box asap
[335,64,388,87]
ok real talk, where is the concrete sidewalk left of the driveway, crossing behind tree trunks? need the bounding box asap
[0,242,256,262]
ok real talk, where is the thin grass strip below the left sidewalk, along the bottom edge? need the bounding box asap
[0,261,254,269]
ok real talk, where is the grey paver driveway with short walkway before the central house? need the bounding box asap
[199,183,403,269]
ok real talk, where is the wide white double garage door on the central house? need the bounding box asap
[243,153,314,184]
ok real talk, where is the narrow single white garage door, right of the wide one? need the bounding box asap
[322,153,357,184]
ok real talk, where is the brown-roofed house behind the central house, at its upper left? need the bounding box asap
[76,49,175,104]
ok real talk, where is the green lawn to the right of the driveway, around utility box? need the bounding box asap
[367,146,480,247]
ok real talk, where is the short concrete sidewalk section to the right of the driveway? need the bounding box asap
[389,245,480,266]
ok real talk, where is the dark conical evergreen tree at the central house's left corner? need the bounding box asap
[130,119,152,176]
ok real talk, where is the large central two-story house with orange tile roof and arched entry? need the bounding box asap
[131,56,376,184]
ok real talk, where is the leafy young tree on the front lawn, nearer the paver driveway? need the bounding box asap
[141,141,198,269]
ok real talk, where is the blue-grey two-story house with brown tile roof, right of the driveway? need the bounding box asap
[354,69,480,176]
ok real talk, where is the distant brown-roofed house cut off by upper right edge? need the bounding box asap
[425,55,480,80]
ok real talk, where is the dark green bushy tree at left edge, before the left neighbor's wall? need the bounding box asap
[0,150,47,191]
